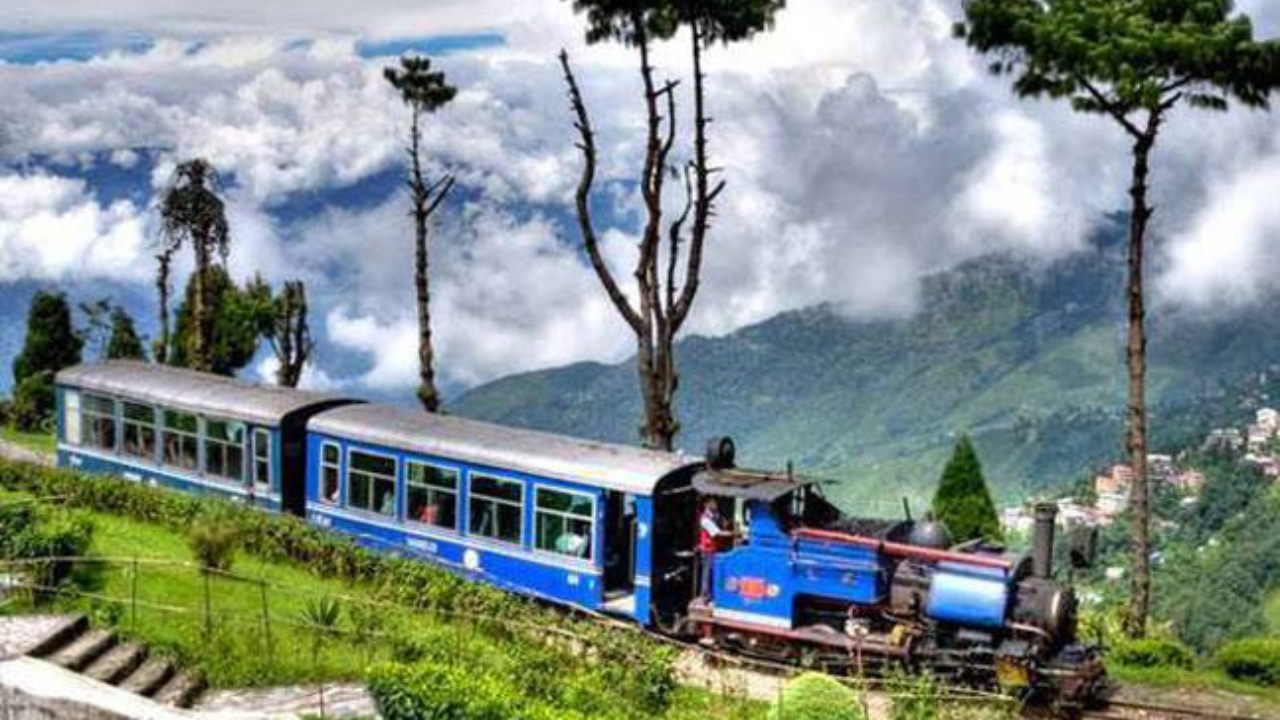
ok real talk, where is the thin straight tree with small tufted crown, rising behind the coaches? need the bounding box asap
[381,56,458,413]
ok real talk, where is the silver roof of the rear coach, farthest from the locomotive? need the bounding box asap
[56,360,342,425]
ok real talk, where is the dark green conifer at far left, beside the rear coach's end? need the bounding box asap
[10,292,84,430]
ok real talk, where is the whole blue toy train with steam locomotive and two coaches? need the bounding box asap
[56,361,1105,705]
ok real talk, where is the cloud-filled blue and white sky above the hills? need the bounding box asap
[0,0,1280,395]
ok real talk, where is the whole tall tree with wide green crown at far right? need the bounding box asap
[956,0,1280,637]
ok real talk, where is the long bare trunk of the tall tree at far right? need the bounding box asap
[1125,113,1160,638]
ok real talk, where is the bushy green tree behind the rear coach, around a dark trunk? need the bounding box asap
[169,265,271,375]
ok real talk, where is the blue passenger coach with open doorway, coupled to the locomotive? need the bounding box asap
[307,405,700,624]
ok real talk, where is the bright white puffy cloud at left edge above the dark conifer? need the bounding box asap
[0,174,150,282]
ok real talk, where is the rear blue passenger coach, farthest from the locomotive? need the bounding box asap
[56,360,352,515]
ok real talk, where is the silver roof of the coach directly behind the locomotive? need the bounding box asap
[308,405,701,495]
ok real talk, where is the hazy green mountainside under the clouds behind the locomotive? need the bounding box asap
[453,231,1280,510]
